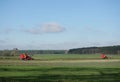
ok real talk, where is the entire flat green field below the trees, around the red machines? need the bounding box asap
[0,54,120,82]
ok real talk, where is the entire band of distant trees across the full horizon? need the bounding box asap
[0,45,120,56]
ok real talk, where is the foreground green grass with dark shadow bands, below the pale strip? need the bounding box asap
[0,62,120,82]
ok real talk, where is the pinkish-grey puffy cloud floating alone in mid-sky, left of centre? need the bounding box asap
[26,23,65,34]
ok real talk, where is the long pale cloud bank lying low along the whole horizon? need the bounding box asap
[0,40,120,50]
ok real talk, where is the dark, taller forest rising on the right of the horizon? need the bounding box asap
[68,45,120,54]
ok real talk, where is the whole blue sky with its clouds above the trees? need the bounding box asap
[0,0,120,50]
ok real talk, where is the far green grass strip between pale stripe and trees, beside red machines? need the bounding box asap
[0,54,120,60]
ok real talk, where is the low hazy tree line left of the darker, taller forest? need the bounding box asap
[0,48,66,56]
